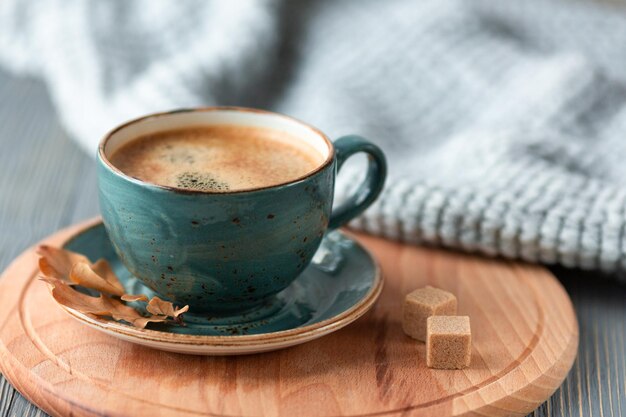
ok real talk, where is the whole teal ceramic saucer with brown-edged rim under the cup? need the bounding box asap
[59,223,382,355]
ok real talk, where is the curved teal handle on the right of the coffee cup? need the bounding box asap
[328,135,387,229]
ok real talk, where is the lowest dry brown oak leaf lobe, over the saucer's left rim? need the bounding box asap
[42,278,167,329]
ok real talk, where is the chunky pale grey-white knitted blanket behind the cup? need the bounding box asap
[0,0,626,271]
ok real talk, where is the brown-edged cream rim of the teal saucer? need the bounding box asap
[59,219,384,347]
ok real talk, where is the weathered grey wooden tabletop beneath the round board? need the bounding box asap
[0,72,626,417]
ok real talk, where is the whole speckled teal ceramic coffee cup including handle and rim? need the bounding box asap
[98,107,386,313]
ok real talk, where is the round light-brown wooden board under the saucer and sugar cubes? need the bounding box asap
[0,221,578,417]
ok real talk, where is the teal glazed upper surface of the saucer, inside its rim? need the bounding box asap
[64,224,378,336]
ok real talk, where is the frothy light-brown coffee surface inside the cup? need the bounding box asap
[109,125,325,192]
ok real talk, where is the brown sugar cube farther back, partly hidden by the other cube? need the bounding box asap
[402,286,456,342]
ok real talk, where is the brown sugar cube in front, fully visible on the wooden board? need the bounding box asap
[426,316,472,369]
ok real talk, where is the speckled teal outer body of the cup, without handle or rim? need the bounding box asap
[99,157,334,311]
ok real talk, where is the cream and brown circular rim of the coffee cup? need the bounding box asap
[98,106,335,195]
